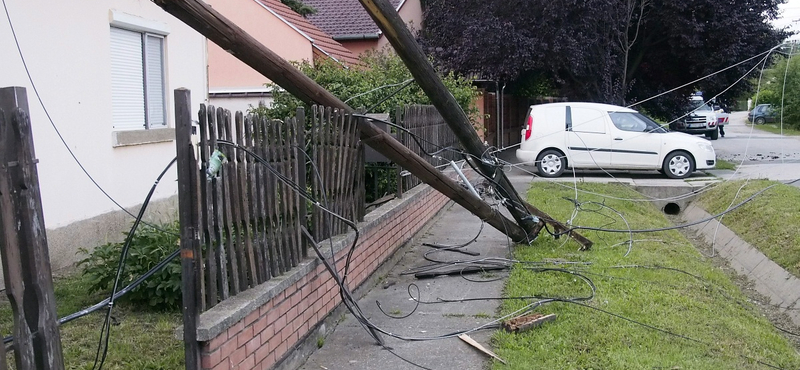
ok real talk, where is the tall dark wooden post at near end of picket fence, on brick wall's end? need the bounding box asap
[175,89,200,370]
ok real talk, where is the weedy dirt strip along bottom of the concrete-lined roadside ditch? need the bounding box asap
[667,216,800,351]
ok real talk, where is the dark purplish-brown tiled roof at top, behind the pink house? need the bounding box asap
[303,0,402,38]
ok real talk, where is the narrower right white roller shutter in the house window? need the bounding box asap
[144,34,167,127]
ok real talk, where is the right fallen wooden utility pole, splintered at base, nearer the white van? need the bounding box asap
[359,0,592,249]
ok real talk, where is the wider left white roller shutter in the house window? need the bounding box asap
[111,27,145,130]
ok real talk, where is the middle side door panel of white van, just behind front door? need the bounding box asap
[566,106,611,168]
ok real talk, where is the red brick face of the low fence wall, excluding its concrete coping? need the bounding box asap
[201,185,448,370]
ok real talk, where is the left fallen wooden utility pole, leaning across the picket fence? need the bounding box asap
[152,0,529,242]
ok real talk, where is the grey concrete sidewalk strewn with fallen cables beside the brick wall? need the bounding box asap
[301,204,509,370]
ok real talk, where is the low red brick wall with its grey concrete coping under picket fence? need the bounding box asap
[198,185,449,370]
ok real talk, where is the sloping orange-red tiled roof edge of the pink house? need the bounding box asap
[256,0,359,65]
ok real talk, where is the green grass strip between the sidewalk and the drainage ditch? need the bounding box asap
[493,182,800,370]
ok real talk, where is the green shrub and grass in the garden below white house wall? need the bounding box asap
[0,222,184,370]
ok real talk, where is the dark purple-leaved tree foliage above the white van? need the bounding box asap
[420,0,786,115]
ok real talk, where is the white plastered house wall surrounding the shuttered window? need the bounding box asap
[0,0,208,268]
